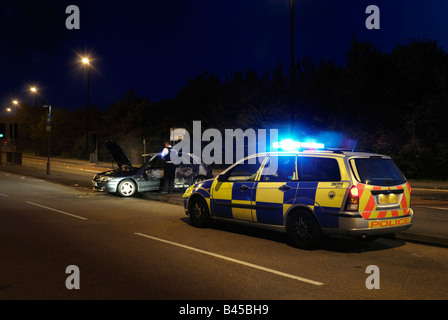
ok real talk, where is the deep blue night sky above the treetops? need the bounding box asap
[0,0,448,115]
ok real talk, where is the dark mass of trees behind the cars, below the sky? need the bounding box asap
[13,39,448,178]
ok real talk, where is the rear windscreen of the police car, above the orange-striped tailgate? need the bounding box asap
[350,157,406,186]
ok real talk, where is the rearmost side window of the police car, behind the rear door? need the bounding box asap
[297,157,341,181]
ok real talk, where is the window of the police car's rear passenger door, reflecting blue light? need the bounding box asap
[260,156,297,182]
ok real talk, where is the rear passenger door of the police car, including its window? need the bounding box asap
[253,154,298,225]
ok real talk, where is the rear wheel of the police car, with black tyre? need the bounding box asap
[286,210,322,249]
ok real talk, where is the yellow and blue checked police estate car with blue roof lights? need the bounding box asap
[183,141,414,248]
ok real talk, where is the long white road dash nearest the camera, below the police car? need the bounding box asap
[134,232,324,286]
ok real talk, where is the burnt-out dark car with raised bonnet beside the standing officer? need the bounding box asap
[92,141,213,197]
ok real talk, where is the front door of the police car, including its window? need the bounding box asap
[210,156,265,221]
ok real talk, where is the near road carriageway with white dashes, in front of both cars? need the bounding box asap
[0,171,448,301]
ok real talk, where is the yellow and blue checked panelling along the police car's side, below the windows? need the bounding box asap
[184,179,348,228]
